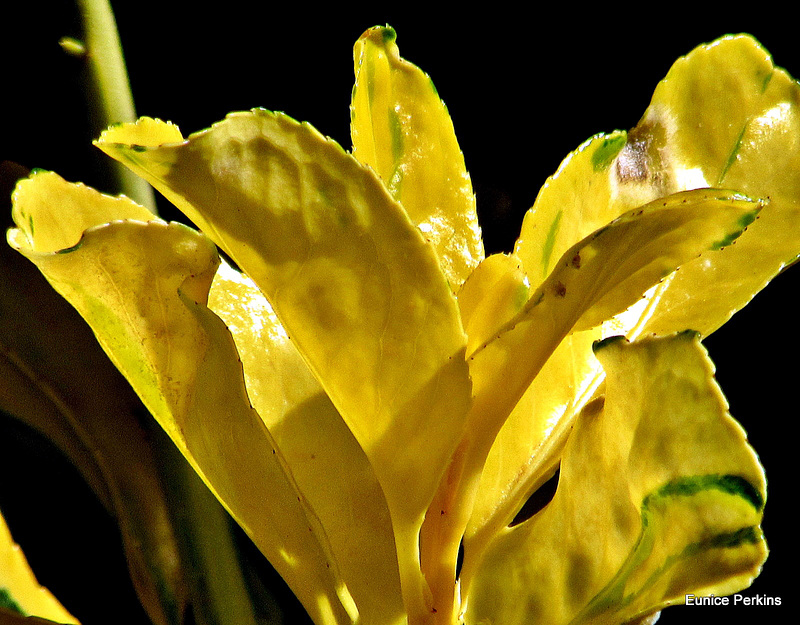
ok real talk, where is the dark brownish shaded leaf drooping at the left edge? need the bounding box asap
[0,182,191,625]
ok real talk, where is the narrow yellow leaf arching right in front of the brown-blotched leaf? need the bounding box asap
[424,189,761,604]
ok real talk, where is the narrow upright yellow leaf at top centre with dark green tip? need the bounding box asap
[350,27,484,291]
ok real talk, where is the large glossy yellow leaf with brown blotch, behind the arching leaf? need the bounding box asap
[465,36,800,566]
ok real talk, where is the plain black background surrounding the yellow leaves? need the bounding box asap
[0,0,800,625]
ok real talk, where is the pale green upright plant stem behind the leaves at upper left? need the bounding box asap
[78,0,156,213]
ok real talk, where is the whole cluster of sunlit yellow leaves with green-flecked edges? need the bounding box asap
[0,28,800,625]
